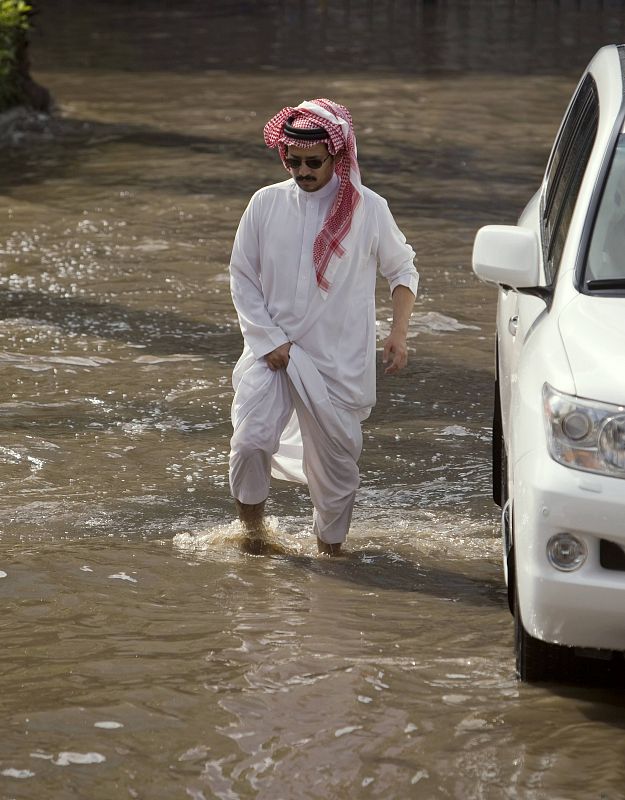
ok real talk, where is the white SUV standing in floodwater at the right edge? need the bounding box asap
[473,45,625,681]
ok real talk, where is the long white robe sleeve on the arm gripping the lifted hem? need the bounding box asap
[230,193,289,359]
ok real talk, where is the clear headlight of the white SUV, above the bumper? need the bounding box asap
[543,383,625,478]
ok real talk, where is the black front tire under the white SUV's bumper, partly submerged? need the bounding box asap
[514,591,578,683]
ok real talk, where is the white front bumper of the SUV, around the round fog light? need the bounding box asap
[513,452,625,650]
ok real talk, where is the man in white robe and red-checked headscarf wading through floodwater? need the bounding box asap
[230,100,419,555]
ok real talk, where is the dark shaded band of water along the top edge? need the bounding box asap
[30,0,624,75]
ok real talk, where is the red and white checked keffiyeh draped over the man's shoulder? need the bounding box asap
[264,98,362,297]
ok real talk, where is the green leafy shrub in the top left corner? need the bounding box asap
[0,0,31,111]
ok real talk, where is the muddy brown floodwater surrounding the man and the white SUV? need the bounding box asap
[0,0,625,800]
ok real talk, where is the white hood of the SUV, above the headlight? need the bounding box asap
[558,294,625,405]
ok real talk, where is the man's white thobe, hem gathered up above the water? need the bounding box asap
[230,175,418,542]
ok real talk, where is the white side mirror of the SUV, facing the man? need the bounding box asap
[473,225,545,294]
